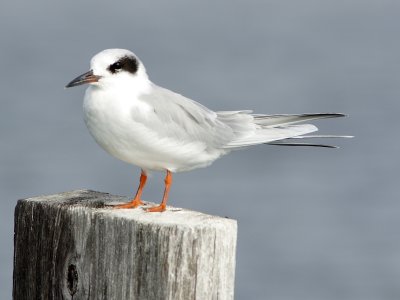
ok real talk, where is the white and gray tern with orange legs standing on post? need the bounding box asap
[66,49,344,212]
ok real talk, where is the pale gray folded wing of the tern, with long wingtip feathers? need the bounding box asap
[134,85,344,149]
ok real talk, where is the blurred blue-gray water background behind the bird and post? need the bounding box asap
[0,0,400,300]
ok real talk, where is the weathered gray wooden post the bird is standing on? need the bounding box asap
[13,190,237,300]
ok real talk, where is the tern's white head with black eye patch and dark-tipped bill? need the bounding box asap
[65,49,148,88]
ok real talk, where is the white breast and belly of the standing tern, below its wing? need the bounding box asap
[83,87,225,172]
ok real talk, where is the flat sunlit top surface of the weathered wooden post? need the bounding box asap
[20,190,237,227]
